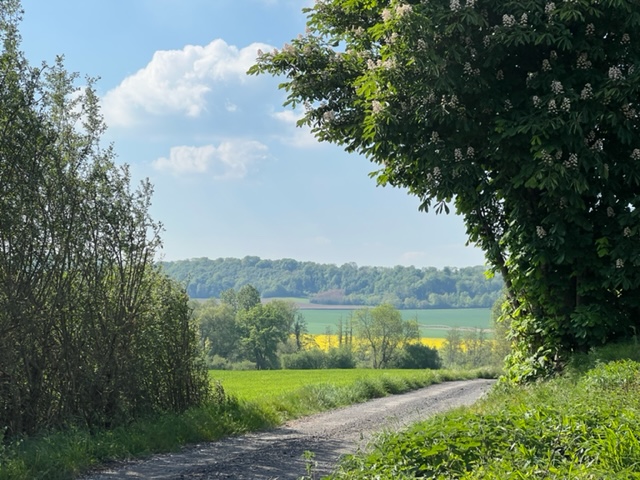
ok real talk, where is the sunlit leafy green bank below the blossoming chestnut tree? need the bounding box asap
[333,344,640,480]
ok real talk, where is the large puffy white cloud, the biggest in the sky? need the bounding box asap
[102,39,273,126]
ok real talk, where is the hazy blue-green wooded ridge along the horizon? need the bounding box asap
[162,256,502,308]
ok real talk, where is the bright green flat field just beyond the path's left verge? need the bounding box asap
[209,368,450,401]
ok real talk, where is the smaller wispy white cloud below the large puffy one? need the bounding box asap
[153,140,267,180]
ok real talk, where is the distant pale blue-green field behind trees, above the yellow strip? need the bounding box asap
[300,308,491,338]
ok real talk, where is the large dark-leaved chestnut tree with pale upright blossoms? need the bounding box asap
[250,0,640,379]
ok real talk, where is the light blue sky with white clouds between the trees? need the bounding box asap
[20,0,485,268]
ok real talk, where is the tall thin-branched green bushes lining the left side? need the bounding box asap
[0,0,209,437]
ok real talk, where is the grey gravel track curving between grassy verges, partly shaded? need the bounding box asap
[84,380,493,480]
